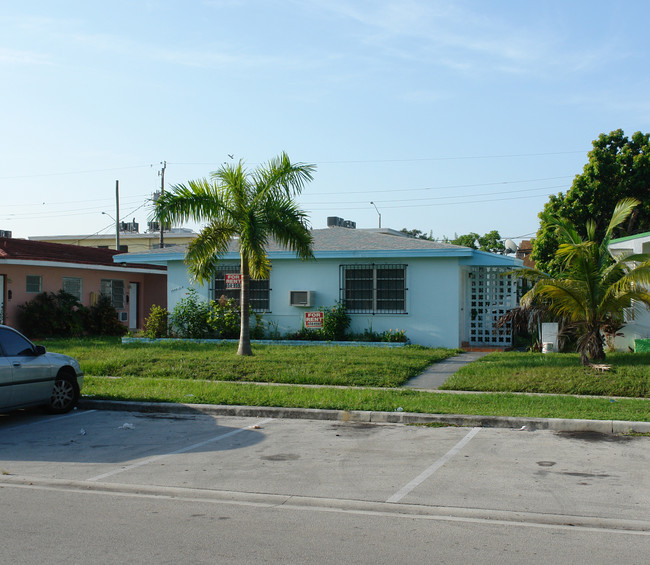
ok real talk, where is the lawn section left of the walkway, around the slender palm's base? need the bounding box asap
[46,338,458,387]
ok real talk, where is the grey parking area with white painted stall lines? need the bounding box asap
[0,409,650,563]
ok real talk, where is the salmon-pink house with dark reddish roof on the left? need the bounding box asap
[0,237,167,329]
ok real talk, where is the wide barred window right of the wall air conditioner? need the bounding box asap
[340,264,407,314]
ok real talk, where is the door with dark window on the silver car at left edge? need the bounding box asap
[0,327,54,406]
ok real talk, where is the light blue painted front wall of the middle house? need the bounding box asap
[167,257,464,347]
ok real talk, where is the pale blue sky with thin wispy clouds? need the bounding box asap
[0,0,650,239]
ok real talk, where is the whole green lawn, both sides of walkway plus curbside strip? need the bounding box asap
[44,339,650,421]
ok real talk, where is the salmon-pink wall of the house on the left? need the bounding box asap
[0,262,167,328]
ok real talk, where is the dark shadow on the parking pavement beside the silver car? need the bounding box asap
[0,409,265,469]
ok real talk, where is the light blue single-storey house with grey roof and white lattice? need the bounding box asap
[115,226,523,347]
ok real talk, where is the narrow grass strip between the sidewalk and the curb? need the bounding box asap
[83,377,650,422]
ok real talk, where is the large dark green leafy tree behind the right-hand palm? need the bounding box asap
[532,129,650,275]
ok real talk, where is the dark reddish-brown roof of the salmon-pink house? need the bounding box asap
[0,237,165,269]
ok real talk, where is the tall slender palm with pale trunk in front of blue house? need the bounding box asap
[155,153,316,355]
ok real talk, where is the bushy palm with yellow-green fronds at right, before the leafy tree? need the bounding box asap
[521,198,650,365]
